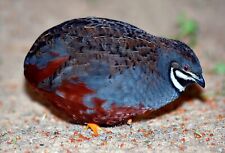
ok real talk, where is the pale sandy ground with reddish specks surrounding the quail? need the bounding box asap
[0,0,225,153]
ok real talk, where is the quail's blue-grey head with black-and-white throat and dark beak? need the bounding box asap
[157,40,205,92]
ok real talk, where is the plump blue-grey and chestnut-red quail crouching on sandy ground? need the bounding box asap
[24,17,205,126]
